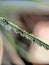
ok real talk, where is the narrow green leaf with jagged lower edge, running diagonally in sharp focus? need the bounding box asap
[0,18,49,50]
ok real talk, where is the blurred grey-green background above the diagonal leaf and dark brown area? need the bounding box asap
[0,0,49,24]
